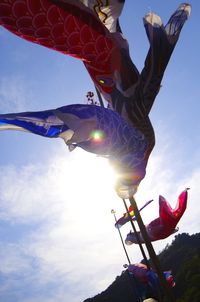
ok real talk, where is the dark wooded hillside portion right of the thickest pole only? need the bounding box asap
[159,233,200,302]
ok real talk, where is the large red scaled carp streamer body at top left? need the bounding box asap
[0,0,120,93]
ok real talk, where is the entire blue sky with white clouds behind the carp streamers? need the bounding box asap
[0,0,200,302]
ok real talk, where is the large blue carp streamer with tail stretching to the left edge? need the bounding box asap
[0,104,147,188]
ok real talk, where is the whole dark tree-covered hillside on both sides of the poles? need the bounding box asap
[84,233,200,302]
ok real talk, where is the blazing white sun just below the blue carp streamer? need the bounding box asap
[52,148,116,204]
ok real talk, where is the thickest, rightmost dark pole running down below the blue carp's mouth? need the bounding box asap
[129,197,175,302]
